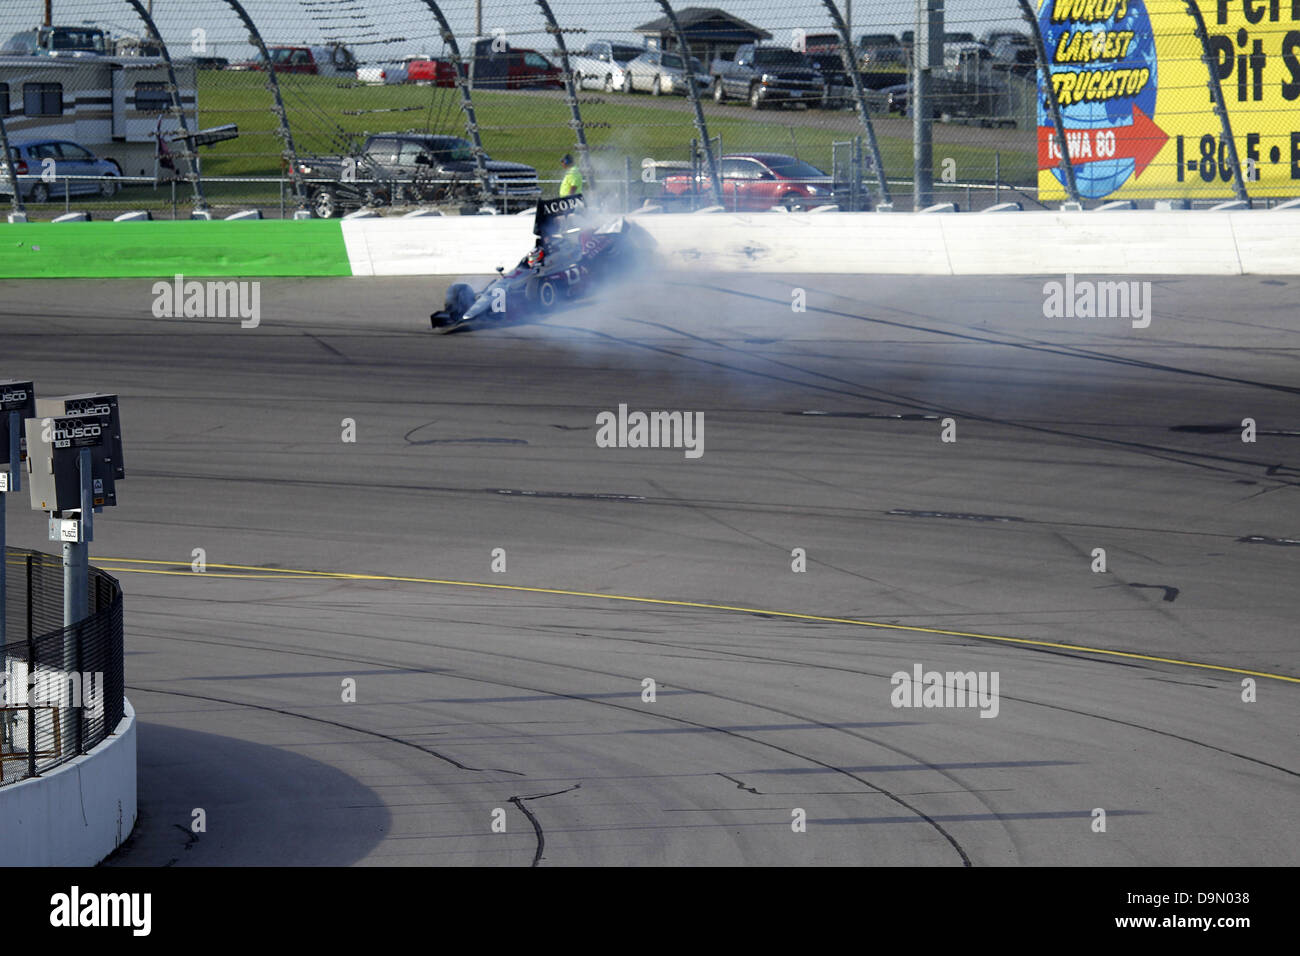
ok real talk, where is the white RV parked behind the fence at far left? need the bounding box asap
[0,56,198,176]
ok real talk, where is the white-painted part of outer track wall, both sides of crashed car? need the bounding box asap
[342,209,1300,276]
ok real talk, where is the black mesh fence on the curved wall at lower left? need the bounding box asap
[0,548,124,786]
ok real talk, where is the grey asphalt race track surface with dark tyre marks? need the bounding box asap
[0,276,1300,866]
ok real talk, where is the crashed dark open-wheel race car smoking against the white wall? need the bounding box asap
[429,194,653,333]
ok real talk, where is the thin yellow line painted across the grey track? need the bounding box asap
[95,558,1300,684]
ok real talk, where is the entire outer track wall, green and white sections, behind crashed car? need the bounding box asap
[0,209,1300,280]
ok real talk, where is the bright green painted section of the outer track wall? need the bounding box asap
[0,220,352,278]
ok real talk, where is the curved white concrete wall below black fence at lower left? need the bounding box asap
[0,701,135,866]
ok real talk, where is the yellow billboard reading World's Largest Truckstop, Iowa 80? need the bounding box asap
[1039,0,1300,199]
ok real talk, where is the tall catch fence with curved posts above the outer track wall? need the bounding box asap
[0,0,1300,219]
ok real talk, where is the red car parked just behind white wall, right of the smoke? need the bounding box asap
[663,152,835,212]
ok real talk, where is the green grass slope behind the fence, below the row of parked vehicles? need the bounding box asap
[199,70,1035,183]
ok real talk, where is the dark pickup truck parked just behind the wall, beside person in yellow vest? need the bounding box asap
[298,133,542,219]
